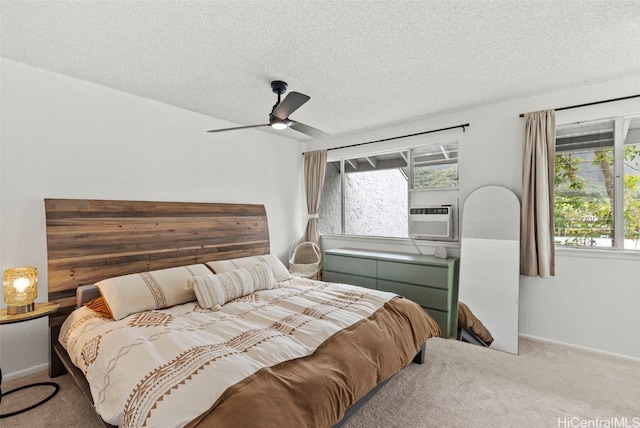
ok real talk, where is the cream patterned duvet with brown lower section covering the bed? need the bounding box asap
[60,279,439,427]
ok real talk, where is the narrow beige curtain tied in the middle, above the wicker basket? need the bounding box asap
[304,150,327,244]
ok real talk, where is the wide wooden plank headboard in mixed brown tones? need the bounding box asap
[44,199,270,327]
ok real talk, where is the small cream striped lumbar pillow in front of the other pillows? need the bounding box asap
[186,262,276,310]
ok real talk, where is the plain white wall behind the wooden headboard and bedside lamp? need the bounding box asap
[0,59,306,379]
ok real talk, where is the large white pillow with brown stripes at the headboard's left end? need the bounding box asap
[96,264,210,320]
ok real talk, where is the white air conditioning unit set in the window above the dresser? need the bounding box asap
[409,205,453,239]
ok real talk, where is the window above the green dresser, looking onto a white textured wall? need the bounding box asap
[318,142,458,238]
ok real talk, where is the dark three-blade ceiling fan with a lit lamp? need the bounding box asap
[207,80,330,140]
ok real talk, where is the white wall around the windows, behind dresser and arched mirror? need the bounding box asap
[322,75,640,358]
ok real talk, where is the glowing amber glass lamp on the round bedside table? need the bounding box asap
[4,266,38,315]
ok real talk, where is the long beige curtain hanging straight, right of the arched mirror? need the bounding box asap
[520,110,556,278]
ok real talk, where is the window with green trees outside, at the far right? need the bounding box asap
[554,116,640,250]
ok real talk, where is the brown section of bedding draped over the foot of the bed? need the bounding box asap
[188,297,440,428]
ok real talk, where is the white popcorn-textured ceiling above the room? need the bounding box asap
[0,0,640,141]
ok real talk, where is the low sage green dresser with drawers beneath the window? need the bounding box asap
[322,248,459,337]
